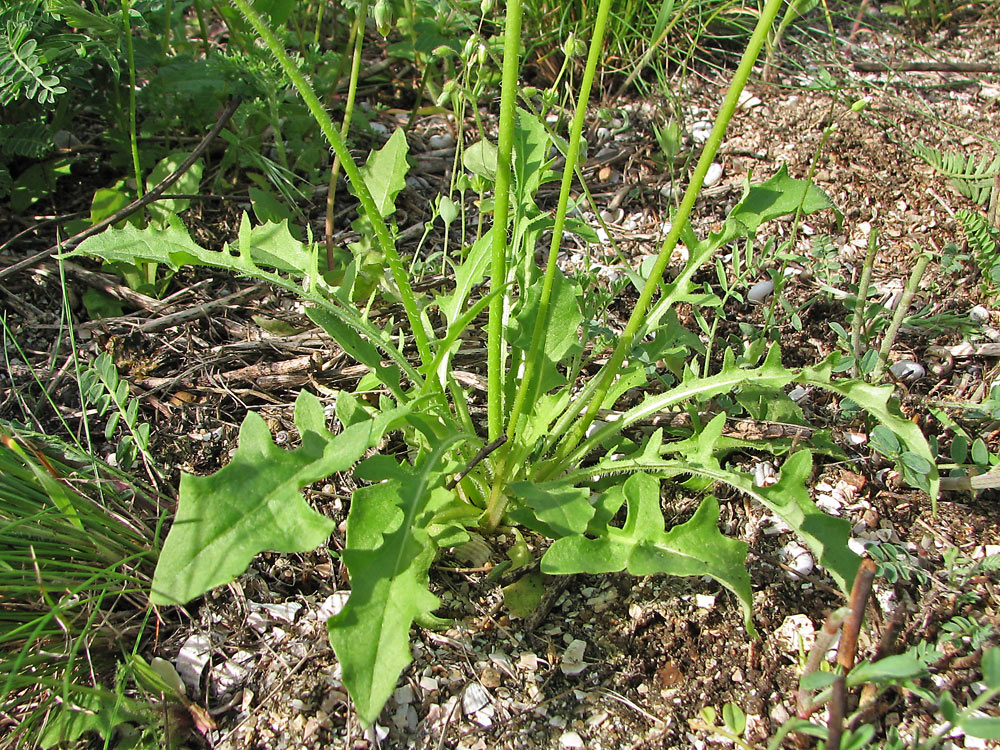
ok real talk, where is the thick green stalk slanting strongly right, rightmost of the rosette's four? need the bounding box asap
[556,0,784,470]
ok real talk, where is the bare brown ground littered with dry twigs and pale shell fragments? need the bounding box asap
[0,2,1000,750]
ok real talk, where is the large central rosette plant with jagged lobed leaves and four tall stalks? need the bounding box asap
[68,0,937,736]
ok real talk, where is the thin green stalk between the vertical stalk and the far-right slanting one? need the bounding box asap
[486,0,611,529]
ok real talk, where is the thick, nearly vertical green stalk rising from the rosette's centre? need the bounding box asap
[488,0,521,442]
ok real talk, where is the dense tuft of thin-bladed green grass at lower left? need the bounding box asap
[0,422,160,748]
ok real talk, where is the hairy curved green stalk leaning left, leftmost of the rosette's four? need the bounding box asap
[232,0,432,363]
